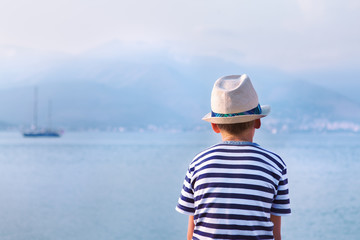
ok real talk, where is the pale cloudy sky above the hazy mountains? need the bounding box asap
[0,0,360,84]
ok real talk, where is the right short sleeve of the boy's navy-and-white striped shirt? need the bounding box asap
[271,168,291,216]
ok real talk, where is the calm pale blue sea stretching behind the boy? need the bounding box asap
[0,131,360,240]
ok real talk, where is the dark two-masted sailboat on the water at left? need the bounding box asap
[23,87,61,137]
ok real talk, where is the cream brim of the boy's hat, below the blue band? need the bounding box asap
[202,105,271,124]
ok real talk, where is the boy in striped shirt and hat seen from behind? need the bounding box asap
[176,74,291,240]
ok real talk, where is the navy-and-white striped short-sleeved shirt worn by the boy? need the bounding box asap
[176,142,291,240]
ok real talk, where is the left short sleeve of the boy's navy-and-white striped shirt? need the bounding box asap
[175,168,195,215]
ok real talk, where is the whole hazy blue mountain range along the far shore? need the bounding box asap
[0,43,360,133]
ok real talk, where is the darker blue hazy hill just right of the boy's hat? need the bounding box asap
[263,80,360,132]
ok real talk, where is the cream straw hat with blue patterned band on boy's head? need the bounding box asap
[203,74,270,124]
